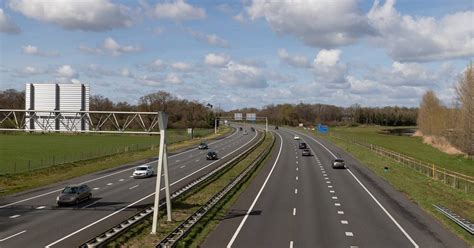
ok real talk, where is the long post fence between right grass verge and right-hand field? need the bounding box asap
[330,133,474,194]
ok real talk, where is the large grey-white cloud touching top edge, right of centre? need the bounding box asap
[247,0,373,47]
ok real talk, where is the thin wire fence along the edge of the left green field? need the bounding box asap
[0,144,158,175]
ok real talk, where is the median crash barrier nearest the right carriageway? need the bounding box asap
[156,131,275,248]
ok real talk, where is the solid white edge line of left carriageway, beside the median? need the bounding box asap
[45,128,260,248]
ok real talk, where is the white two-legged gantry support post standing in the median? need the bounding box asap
[151,112,171,234]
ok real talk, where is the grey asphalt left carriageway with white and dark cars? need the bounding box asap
[0,125,259,248]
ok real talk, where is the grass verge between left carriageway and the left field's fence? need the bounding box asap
[0,127,232,196]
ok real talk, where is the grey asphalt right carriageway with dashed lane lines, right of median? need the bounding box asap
[202,128,468,248]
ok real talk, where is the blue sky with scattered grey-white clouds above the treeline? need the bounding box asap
[0,0,474,109]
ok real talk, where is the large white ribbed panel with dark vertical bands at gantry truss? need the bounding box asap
[25,84,90,131]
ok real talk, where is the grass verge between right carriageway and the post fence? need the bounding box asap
[312,133,474,246]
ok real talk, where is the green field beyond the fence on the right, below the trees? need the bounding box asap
[330,126,474,176]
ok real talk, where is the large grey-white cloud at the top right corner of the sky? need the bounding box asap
[367,0,474,62]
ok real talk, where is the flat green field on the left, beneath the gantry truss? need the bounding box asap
[0,129,213,174]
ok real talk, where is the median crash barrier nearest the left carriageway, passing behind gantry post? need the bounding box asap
[79,130,265,248]
